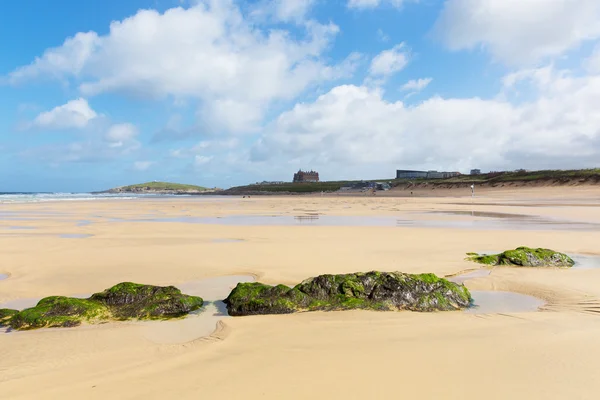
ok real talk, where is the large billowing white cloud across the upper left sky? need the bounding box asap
[8,0,354,135]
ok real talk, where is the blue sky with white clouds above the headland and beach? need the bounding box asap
[0,0,600,192]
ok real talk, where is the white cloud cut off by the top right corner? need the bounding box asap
[435,0,600,65]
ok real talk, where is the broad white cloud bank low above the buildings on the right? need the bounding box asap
[252,59,600,179]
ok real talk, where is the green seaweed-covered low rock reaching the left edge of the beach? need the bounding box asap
[0,282,203,330]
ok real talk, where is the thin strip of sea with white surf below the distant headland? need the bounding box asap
[0,192,185,203]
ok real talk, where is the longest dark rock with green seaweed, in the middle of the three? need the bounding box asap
[225,271,472,316]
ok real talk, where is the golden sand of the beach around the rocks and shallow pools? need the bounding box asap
[0,187,600,399]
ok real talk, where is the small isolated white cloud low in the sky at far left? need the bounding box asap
[31,98,98,129]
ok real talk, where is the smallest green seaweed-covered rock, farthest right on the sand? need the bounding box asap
[467,247,575,267]
